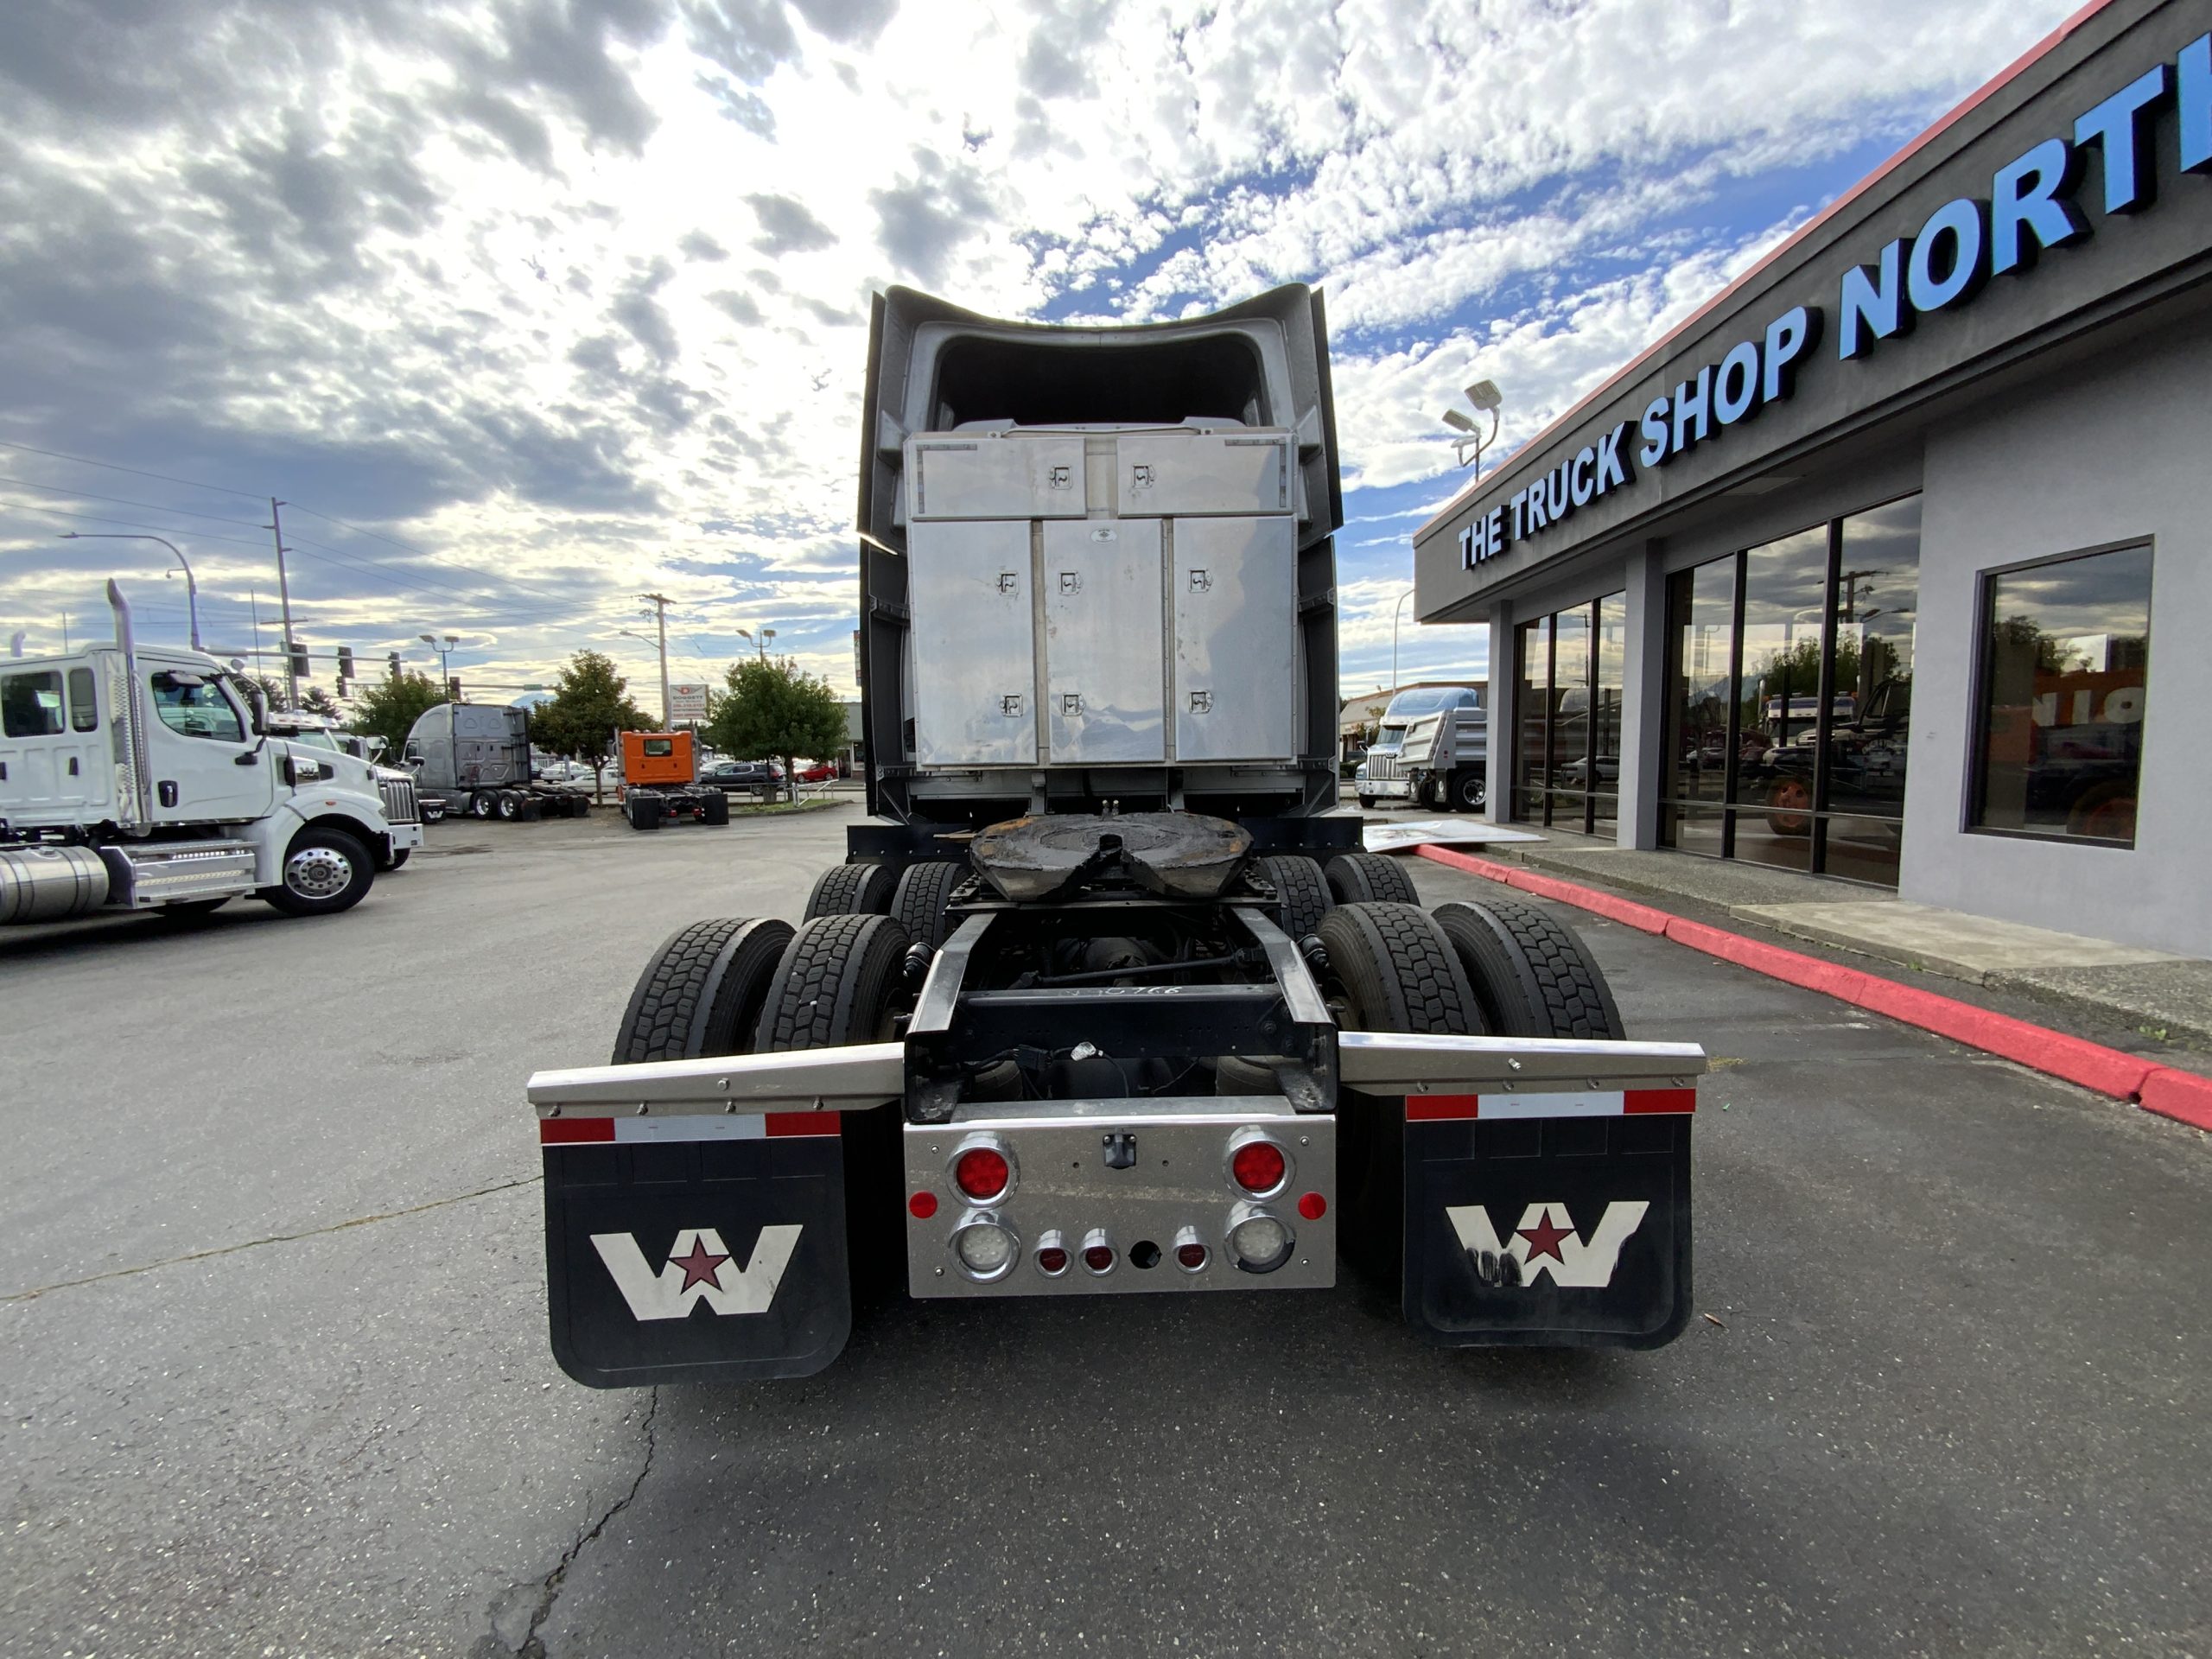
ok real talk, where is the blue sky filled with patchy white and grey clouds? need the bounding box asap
[0,0,2073,706]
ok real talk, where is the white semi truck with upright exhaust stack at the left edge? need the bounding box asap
[0,582,423,925]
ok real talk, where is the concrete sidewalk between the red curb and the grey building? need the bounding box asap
[1482,830,2212,1048]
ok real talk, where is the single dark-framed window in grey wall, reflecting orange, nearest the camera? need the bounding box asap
[1974,546,2150,847]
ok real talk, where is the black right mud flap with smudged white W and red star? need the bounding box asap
[1405,1115,1697,1347]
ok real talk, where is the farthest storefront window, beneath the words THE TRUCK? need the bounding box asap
[1513,593,1628,834]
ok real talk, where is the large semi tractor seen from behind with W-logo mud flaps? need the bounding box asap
[526,288,1706,1387]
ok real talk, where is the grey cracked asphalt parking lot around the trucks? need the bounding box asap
[0,805,2212,1656]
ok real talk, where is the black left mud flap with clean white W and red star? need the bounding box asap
[542,1113,852,1389]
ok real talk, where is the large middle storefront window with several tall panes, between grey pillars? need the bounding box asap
[1662,495,1920,885]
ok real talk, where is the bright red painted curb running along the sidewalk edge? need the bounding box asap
[1414,845,2212,1130]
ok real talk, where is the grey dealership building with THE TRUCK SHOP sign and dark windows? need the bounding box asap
[1414,0,2212,956]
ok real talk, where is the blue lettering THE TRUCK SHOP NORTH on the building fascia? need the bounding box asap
[1460,33,2212,570]
